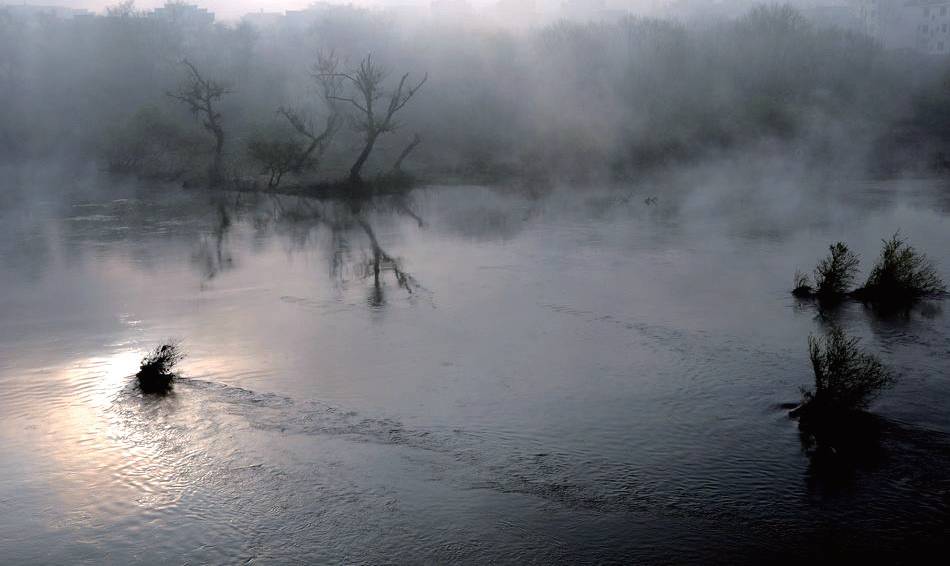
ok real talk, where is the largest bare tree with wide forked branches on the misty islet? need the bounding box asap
[317,54,429,184]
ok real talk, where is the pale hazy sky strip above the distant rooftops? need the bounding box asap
[0,0,657,18]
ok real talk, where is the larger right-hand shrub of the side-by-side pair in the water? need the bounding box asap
[855,233,946,303]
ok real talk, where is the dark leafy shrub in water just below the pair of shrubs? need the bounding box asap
[795,328,894,417]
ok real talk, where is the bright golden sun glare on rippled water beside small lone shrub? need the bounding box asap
[0,345,193,529]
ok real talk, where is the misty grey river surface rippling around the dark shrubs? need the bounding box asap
[0,171,950,564]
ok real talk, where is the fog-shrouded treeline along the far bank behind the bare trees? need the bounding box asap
[0,5,950,184]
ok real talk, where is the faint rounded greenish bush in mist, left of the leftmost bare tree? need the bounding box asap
[102,106,203,179]
